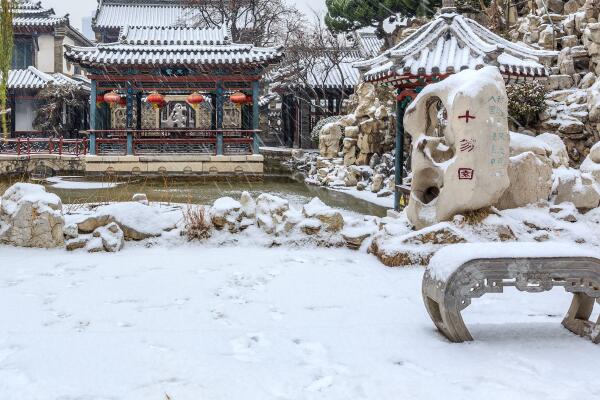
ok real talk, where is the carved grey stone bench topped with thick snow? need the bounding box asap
[422,243,600,343]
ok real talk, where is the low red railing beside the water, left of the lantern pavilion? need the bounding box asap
[0,137,88,156]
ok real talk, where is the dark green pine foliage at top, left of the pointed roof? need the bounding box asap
[325,0,441,34]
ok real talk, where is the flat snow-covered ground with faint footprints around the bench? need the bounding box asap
[0,246,600,400]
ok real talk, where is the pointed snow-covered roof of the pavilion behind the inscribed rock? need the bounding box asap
[354,9,558,82]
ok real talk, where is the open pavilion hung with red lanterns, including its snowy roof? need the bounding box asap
[65,26,283,156]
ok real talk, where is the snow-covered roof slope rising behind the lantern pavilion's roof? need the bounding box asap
[93,0,198,29]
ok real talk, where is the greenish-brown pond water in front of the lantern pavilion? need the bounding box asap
[0,176,386,217]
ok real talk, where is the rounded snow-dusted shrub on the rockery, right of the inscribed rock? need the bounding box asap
[506,81,548,127]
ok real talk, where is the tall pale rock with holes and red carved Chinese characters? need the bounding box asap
[404,67,510,229]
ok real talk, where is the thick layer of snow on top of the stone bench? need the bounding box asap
[427,242,600,282]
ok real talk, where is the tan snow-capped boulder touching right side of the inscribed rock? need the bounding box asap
[496,151,552,210]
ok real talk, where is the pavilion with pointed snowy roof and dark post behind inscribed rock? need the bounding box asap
[354,0,558,209]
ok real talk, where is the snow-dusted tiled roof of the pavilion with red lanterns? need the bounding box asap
[65,27,283,67]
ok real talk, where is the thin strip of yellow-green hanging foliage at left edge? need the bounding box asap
[0,0,17,139]
